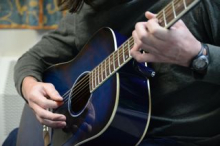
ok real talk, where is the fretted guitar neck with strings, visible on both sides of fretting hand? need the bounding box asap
[89,0,200,92]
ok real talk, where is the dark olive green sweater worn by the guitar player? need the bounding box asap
[14,0,220,144]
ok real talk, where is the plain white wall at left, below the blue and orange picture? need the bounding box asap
[0,29,47,145]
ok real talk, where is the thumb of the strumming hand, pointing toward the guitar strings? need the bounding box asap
[44,83,63,102]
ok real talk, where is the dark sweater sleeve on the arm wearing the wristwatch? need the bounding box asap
[183,0,220,84]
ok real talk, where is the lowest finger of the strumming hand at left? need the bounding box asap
[36,115,66,128]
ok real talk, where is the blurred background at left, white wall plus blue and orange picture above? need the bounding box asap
[0,0,65,145]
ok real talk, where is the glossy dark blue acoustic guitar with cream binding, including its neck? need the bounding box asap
[18,0,200,146]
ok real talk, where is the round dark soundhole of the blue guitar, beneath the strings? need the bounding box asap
[69,73,91,117]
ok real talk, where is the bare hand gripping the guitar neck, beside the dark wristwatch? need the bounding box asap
[130,12,201,66]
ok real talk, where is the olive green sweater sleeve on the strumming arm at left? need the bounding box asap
[14,14,78,96]
